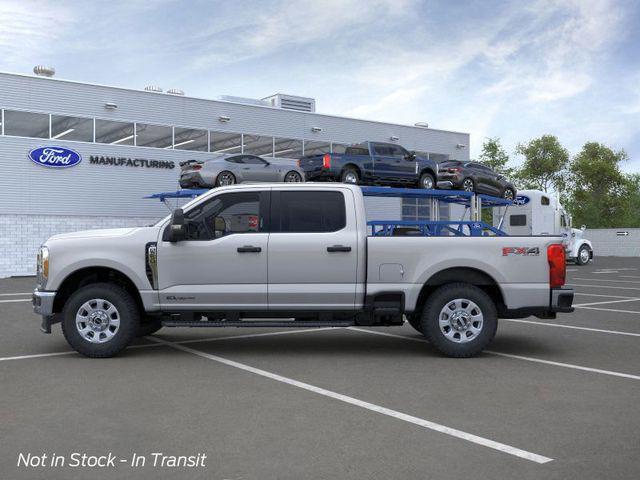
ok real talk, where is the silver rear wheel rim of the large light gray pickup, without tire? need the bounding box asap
[438,298,484,343]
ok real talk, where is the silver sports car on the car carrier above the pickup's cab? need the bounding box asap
[180,154,304,188]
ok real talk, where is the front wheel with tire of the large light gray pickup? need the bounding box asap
[62,283,140,358]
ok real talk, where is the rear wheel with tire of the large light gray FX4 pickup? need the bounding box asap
[422,283,498,358]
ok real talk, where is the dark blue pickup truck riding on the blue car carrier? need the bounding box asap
[298,142,440,189]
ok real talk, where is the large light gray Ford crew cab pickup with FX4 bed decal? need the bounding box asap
[33,183,573,357]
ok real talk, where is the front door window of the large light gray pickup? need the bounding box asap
[184,192,266,240]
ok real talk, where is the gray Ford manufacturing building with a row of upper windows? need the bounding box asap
[0,67,469,277]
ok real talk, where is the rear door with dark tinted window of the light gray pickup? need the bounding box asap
[268,189,358,310]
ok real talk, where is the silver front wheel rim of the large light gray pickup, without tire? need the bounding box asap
[76,298,120,343]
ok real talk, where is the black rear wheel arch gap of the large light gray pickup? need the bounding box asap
[414,267,506,314]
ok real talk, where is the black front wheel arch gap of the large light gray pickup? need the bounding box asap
[53,266,144,313]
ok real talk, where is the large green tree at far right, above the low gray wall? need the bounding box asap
[568,142,640,228]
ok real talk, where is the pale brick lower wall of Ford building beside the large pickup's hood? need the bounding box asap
[0,215,159,278]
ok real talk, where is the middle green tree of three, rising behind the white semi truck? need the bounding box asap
[516,135,569,192]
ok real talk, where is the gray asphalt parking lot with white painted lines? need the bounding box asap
[0,257,640,480]
